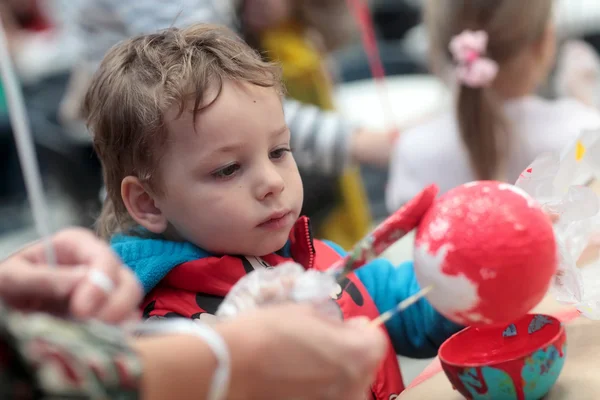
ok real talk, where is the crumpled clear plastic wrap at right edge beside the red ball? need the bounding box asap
[516,131,600,319]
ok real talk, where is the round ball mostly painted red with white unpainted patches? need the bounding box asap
[414,181,557,326]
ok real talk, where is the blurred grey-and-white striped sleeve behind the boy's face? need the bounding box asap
[284,99,355,175]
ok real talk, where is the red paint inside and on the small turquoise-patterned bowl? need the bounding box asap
[439,314,566,400]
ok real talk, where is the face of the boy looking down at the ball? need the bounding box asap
[155,81,303,256]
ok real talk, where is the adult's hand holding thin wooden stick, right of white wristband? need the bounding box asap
[221,305,387,400]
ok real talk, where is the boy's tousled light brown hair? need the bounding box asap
[84,25,282,238]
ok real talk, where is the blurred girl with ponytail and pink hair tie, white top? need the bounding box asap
[386,0,600,211]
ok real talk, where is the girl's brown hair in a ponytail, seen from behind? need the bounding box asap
[425,0,553,179]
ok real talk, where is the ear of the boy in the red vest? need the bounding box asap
[121,176,168,234]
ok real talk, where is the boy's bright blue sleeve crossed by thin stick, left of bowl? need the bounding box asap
[356,259,462,358]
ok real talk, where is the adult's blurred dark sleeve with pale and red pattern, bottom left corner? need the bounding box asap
[0,305,142,400]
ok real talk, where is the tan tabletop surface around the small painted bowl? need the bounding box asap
[399,296,600,400]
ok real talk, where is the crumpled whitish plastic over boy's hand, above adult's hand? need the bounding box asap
[216,262,342,319]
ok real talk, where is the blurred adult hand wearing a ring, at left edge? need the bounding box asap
[0,228,143,323]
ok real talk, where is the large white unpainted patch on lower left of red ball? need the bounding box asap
[414,244,479,320]
